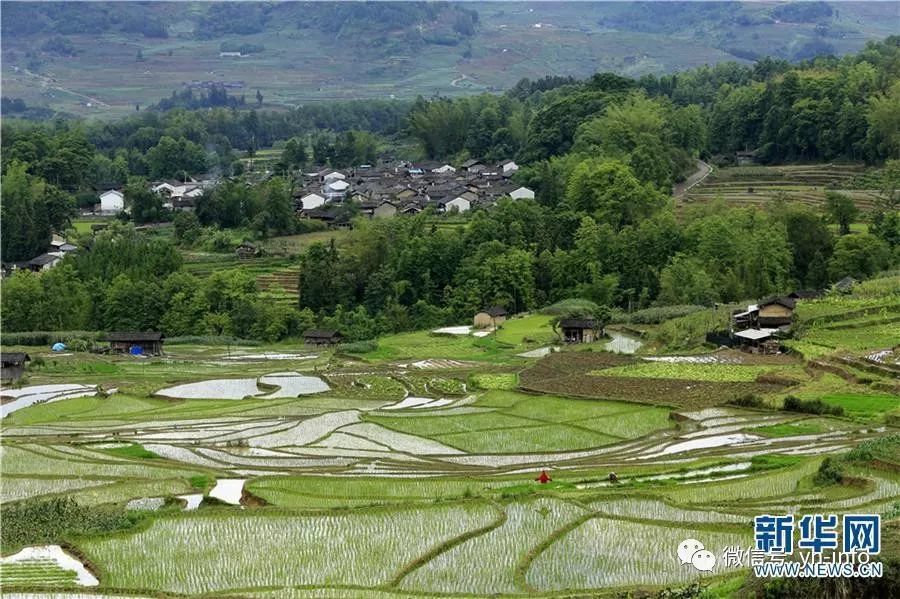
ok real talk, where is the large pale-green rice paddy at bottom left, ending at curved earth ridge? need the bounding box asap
[83,504,498,593]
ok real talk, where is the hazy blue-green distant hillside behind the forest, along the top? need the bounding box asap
[2,2,898,116]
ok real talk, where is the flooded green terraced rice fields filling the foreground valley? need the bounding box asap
[0,288,900,599]
